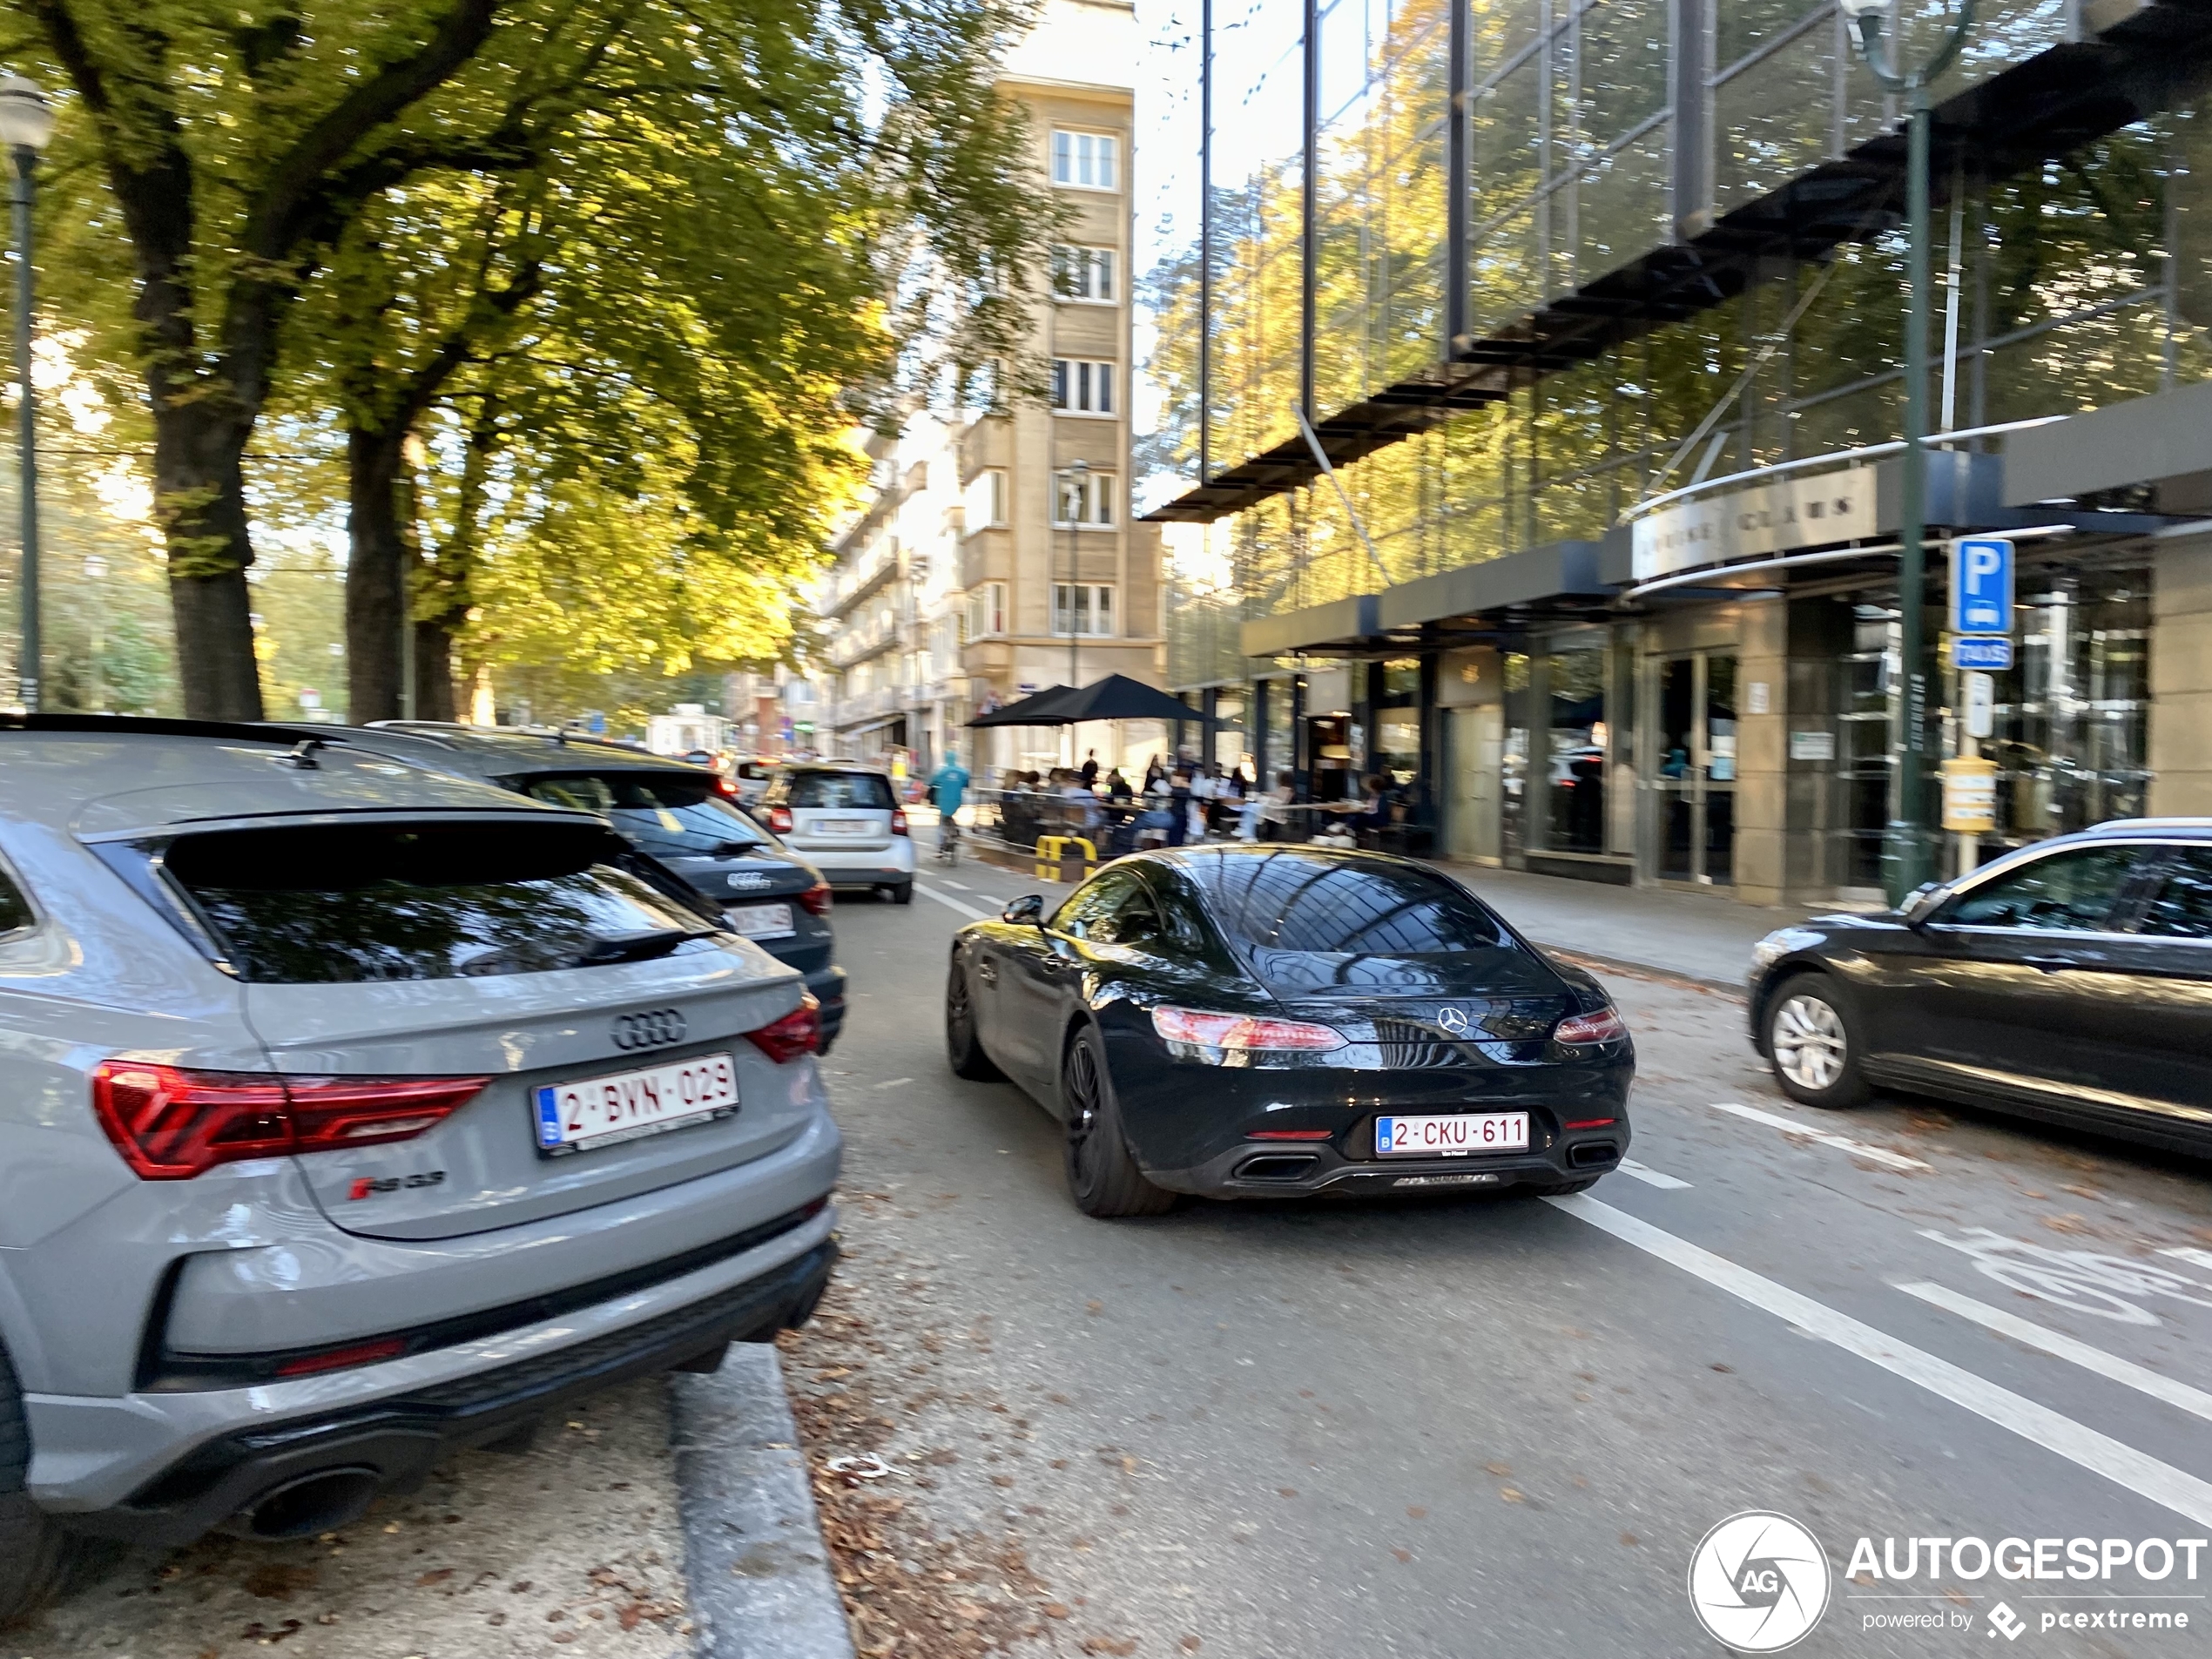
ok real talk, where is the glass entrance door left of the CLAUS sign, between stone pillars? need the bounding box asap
[1650,651,1737,887]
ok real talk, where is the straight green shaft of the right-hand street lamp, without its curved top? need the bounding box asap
[1883,91,1936,905]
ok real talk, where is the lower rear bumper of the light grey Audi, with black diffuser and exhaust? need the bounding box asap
[26,1212,836,1544]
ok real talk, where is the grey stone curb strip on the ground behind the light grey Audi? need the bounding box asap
[668,1343,853,1659]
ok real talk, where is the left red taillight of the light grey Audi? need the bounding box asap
[93,1060,491,1181]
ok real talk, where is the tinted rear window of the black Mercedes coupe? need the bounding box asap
[1190,852,1557,995]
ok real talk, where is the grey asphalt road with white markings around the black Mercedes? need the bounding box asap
[792,865,2212,1659]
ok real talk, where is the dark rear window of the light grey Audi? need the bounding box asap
[164,825,710,984]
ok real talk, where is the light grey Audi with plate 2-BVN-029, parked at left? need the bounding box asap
[0,714,840,1623]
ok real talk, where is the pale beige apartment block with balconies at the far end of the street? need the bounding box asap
[816,0,1163,772]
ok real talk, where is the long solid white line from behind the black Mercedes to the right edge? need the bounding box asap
[1544,1192,2212,1527]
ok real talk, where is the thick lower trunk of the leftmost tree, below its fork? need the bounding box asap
[152,402,261,721]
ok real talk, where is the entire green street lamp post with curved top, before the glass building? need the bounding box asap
[1838,0,1975,905]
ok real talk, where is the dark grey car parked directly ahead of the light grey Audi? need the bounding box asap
[316,721,845,1053]
